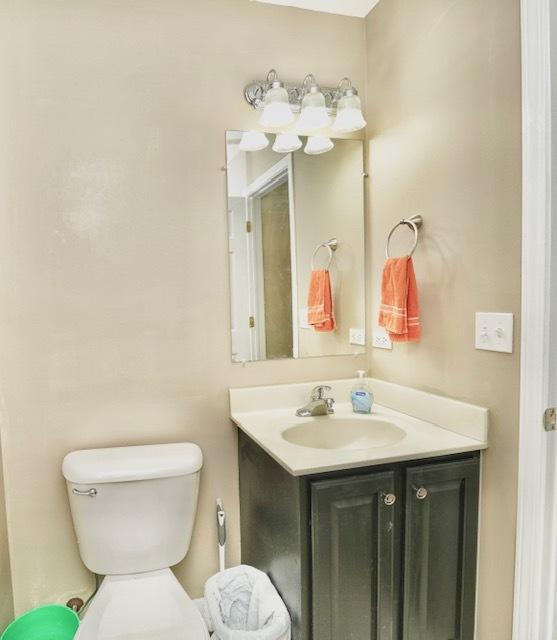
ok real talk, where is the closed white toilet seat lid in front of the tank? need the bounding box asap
[75,569,209,640]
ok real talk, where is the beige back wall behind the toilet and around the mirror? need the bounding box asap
[0,0,365,612]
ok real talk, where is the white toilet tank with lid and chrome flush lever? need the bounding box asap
[62,443,203,575]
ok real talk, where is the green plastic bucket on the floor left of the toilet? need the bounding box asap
[0,604,79,640]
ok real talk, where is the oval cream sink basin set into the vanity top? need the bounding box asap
[282,416,406,450]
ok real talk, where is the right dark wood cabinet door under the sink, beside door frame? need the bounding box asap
[403,459,479,640]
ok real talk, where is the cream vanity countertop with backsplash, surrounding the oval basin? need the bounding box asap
[230,378,488,476]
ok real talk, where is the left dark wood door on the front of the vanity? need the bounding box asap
[311,471,401,640]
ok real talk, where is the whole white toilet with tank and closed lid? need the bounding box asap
[62,443,209,640]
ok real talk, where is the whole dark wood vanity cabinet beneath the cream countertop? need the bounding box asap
[239,432,479,640]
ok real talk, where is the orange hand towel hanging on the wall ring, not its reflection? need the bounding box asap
[379,256,420,342]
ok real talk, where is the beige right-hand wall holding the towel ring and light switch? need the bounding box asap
[366,0,521,640]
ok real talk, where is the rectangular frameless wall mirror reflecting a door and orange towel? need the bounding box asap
[226,131,365,362]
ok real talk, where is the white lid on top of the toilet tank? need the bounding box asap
[62,442,203,484]
